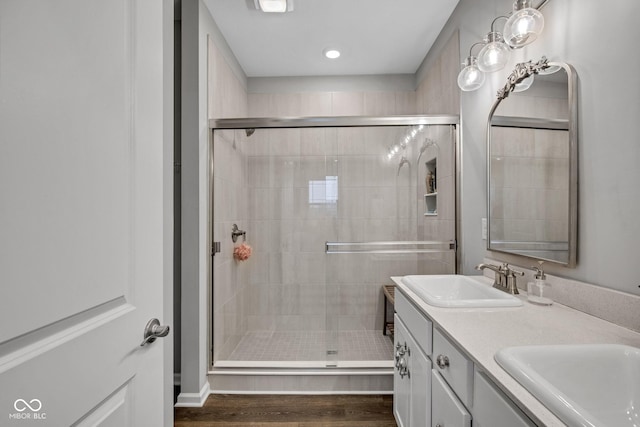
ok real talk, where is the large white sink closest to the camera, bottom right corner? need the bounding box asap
[495,344,640,427]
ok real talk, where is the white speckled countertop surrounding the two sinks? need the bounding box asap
[391,276,640,427]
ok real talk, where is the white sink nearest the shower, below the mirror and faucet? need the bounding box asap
[402,274,522,308]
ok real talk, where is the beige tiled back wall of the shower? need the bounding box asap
[238,79,455,338]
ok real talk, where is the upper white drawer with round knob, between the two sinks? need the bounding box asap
[433,328,473,408]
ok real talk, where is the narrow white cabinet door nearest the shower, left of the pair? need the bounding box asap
[393,314,411,427]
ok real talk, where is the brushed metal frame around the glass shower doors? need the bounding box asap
[207,114,462,367]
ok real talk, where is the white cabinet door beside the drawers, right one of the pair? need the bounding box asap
[409,337,431,427]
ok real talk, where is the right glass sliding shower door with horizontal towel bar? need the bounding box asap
[325,125,456,367]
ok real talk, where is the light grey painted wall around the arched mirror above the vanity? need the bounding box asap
[425,0,640,294]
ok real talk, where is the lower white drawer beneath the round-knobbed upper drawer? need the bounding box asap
[431,369,471,427]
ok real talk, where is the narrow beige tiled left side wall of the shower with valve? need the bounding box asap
[210,40,251,360]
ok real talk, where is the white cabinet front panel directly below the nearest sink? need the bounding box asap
[473,370,535,427]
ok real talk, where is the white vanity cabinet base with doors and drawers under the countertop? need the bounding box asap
[393,292,535,427]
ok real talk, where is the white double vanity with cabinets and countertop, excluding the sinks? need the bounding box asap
[392,276,640,427]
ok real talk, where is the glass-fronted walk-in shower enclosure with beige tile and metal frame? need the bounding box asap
[210,116,459,369]
